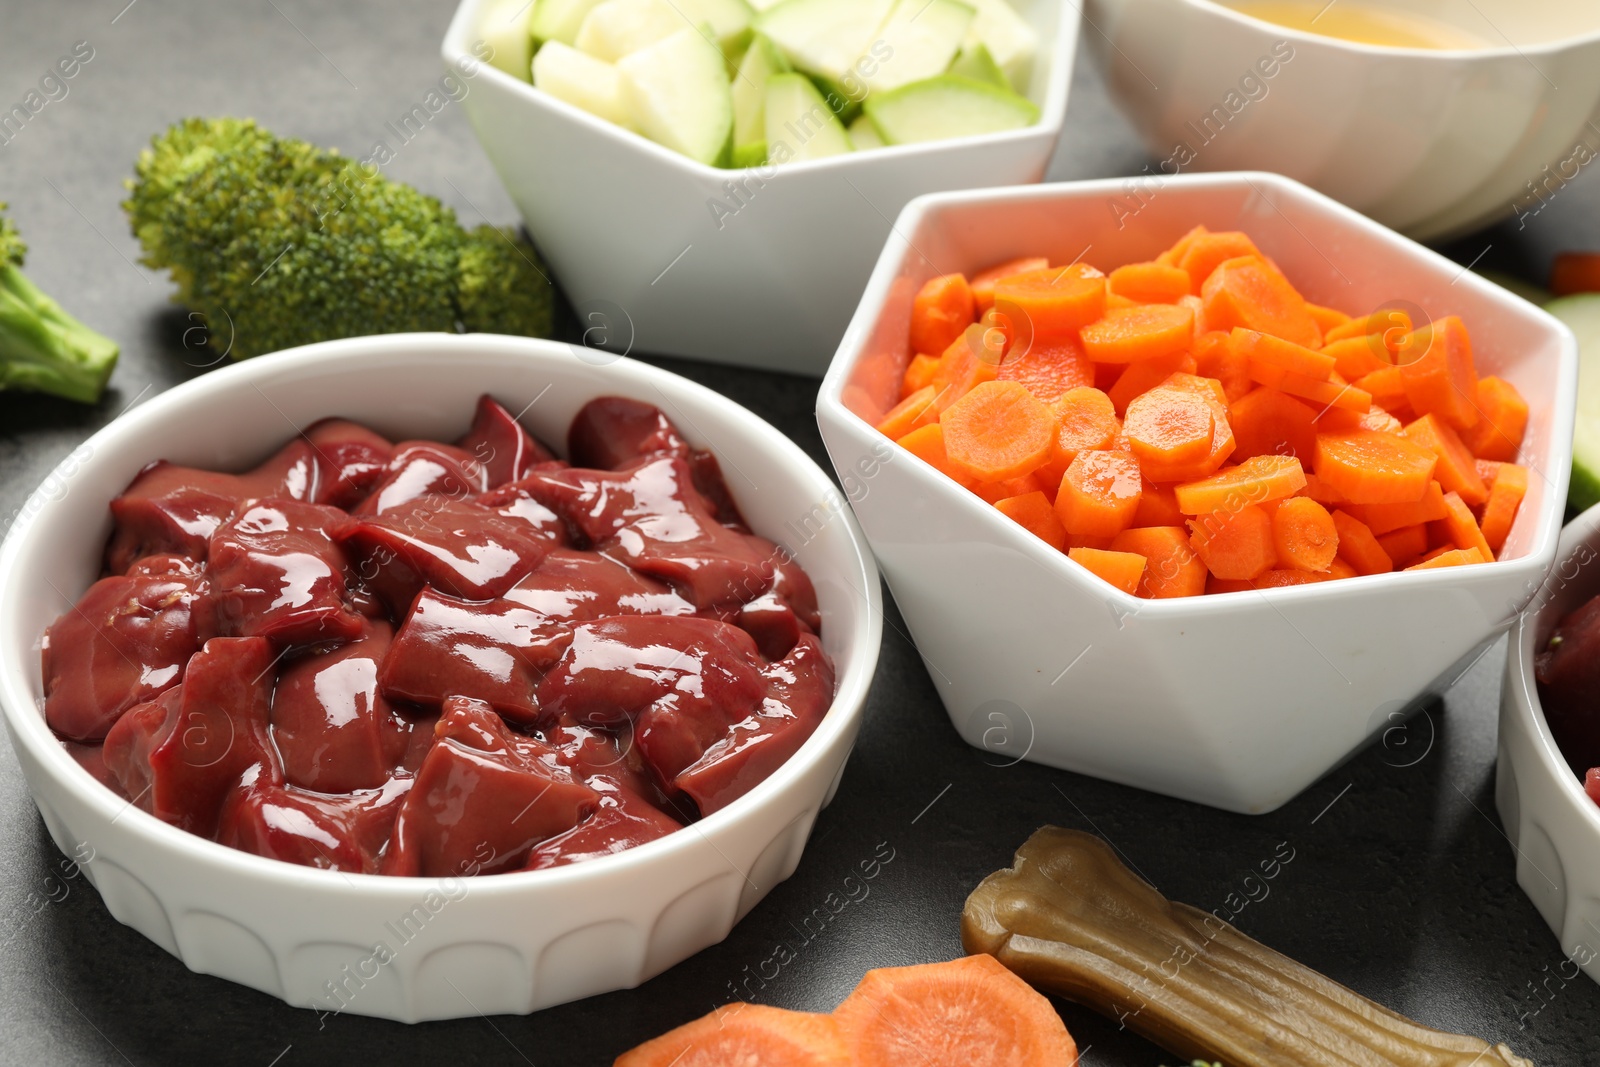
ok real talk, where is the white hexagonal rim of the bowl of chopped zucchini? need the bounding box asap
[440,0,1080,181]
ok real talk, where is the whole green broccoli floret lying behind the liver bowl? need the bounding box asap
[123,118,555,358]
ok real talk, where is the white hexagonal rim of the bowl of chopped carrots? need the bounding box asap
[816,171,1578,619]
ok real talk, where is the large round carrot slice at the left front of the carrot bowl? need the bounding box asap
[939,382,1056,482]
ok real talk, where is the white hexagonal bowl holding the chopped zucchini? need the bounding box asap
[443,0,1078,374]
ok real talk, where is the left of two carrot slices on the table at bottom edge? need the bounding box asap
[614,1003,857,1067]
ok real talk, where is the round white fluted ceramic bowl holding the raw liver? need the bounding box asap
[0,334,882,1022]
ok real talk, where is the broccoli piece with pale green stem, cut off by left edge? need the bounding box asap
[0,200,117,403]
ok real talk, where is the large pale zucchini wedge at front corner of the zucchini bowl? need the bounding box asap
[614,28,733,163]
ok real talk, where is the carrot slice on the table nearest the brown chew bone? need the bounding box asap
[832,955,1078,1067]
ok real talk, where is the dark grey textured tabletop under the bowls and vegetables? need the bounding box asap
[0,0,1600,1067]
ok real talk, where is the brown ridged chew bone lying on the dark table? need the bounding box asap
[962,827,1533,1067]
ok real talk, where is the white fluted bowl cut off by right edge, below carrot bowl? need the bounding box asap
[1494,506,1600,982]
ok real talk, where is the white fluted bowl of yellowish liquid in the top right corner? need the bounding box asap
[1088,0,1600,240]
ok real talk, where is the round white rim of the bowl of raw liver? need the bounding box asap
[0,333,883,899]
